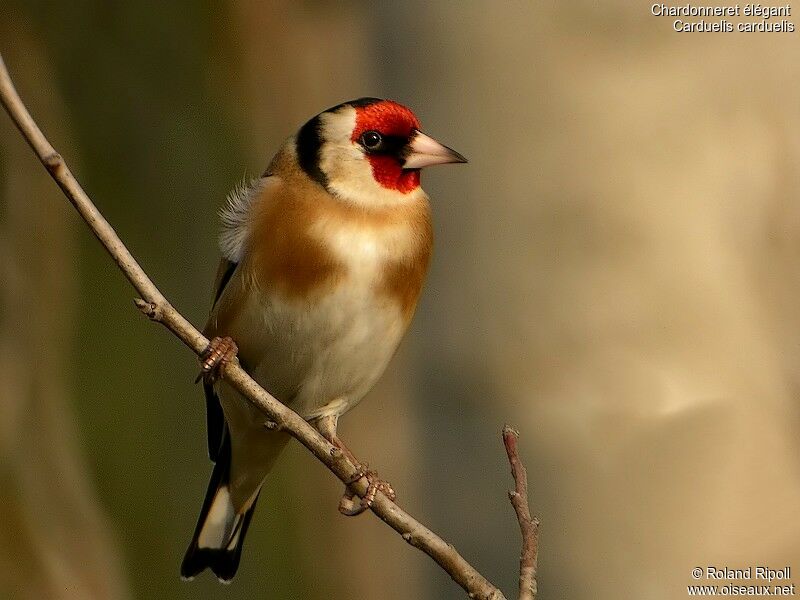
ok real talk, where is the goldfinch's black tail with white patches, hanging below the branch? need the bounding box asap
[181,431,258,583]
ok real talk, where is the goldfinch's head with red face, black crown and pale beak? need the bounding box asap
[296,98,467,206]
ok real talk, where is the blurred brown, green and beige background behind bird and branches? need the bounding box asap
[0,0,800,600]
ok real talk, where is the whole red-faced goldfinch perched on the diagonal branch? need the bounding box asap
[181,98,467,583]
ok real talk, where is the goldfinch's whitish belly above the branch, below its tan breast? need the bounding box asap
[222,270,405,419]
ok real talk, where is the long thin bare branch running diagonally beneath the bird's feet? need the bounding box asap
[0,50,532,600]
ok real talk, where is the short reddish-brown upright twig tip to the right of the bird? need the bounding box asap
[503,425,539,600]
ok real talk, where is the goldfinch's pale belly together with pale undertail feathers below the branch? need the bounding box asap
[218,276,404,506]
